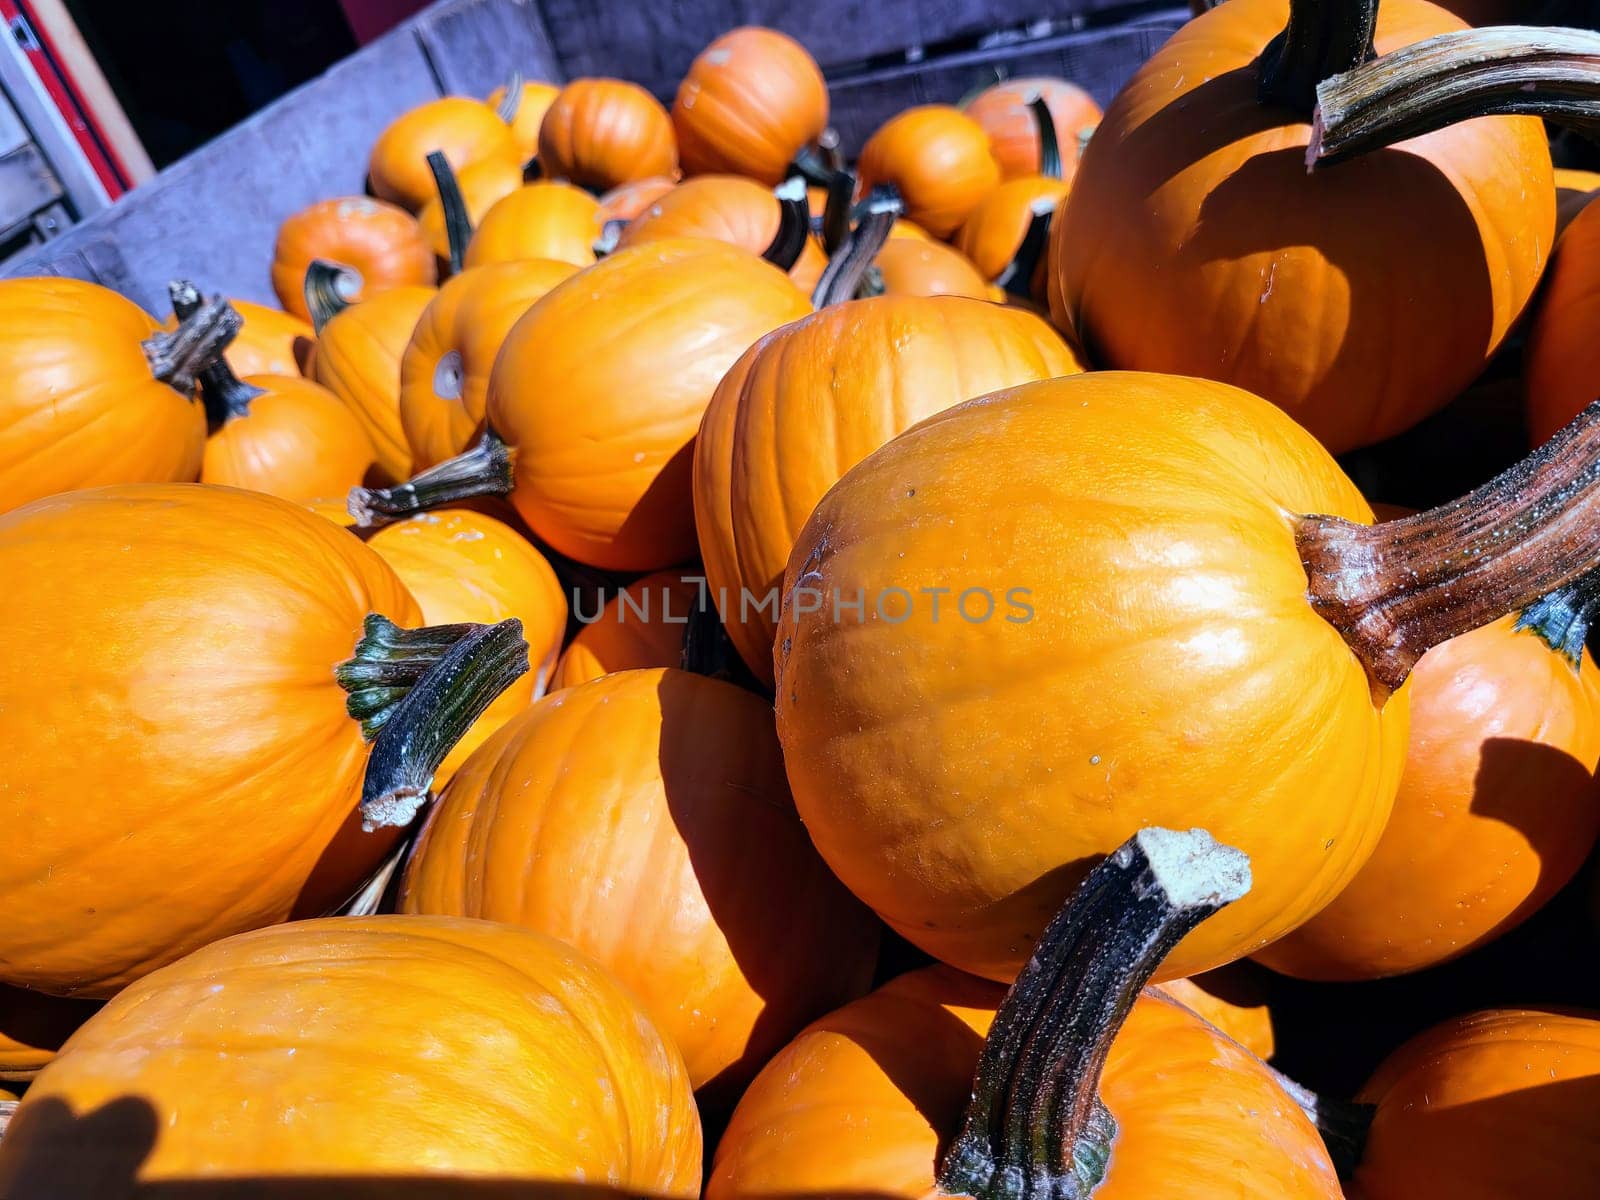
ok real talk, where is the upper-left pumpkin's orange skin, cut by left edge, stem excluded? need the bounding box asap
[0,278,205,512]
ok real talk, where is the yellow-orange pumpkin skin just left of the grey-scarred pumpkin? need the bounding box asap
[312,288,438,483]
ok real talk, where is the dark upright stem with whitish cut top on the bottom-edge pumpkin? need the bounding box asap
[938,829,1250,1200]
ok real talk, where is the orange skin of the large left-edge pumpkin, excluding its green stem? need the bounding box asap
[0,485,421,995]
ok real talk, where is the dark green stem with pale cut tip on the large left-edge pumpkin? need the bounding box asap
[345,613,528,830]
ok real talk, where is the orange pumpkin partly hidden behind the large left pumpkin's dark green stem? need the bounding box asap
[366,509,566,790]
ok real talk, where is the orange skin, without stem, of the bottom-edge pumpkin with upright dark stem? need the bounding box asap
[706,966,1341,1200]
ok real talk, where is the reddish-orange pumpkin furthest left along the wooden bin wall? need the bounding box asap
[268,195,438,321]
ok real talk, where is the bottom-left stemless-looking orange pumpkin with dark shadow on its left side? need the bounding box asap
[0,921,701,1197]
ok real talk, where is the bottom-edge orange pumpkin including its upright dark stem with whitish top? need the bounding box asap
[706,830,1341,1200]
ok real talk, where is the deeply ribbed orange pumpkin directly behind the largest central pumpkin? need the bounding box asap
[694,299,1082,683]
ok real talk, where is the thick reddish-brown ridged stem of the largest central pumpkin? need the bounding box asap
[1294,400,1600,696]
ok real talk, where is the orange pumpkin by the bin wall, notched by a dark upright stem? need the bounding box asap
[366,96,523,213]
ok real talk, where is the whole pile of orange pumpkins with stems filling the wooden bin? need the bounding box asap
[0,0,1600,1200]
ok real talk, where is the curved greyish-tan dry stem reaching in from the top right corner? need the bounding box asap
[1306,26,1600,166]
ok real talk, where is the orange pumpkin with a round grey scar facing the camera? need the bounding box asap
[400,259,578,470]
